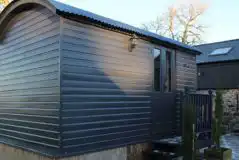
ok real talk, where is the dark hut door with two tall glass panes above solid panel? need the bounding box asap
[151,48,176,140]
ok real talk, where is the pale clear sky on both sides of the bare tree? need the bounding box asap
[59,0,239,43]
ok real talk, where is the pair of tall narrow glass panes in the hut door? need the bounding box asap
[153,49,173,92]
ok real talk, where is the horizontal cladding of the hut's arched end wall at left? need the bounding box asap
[0,7,60,154]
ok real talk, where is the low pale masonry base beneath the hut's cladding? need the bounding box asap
[0,143,150,160]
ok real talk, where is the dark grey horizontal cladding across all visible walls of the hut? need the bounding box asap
[0,3,200,156]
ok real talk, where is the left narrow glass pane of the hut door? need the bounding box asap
[153,49,161,91]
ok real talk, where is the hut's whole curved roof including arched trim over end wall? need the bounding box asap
[0,0,201,54]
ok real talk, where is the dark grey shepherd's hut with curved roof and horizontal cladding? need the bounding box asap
[0,0,211,157]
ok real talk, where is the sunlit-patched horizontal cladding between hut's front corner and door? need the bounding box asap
[61,19,153,153]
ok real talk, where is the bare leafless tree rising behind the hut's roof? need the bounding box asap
[143,4,207,45]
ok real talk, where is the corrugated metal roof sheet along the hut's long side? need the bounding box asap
[49,0,200,54]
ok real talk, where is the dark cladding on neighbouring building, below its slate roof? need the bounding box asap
[198,61,239,89]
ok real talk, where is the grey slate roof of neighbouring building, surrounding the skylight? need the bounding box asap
[195,39,239,64]
